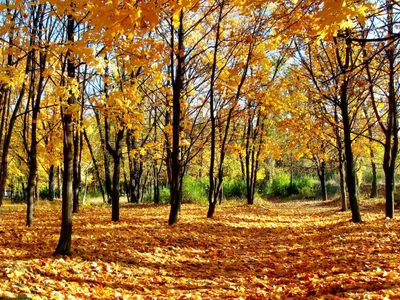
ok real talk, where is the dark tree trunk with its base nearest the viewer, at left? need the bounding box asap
[54,11,76,255]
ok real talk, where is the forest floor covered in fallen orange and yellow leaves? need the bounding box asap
[0,199,400,299]
